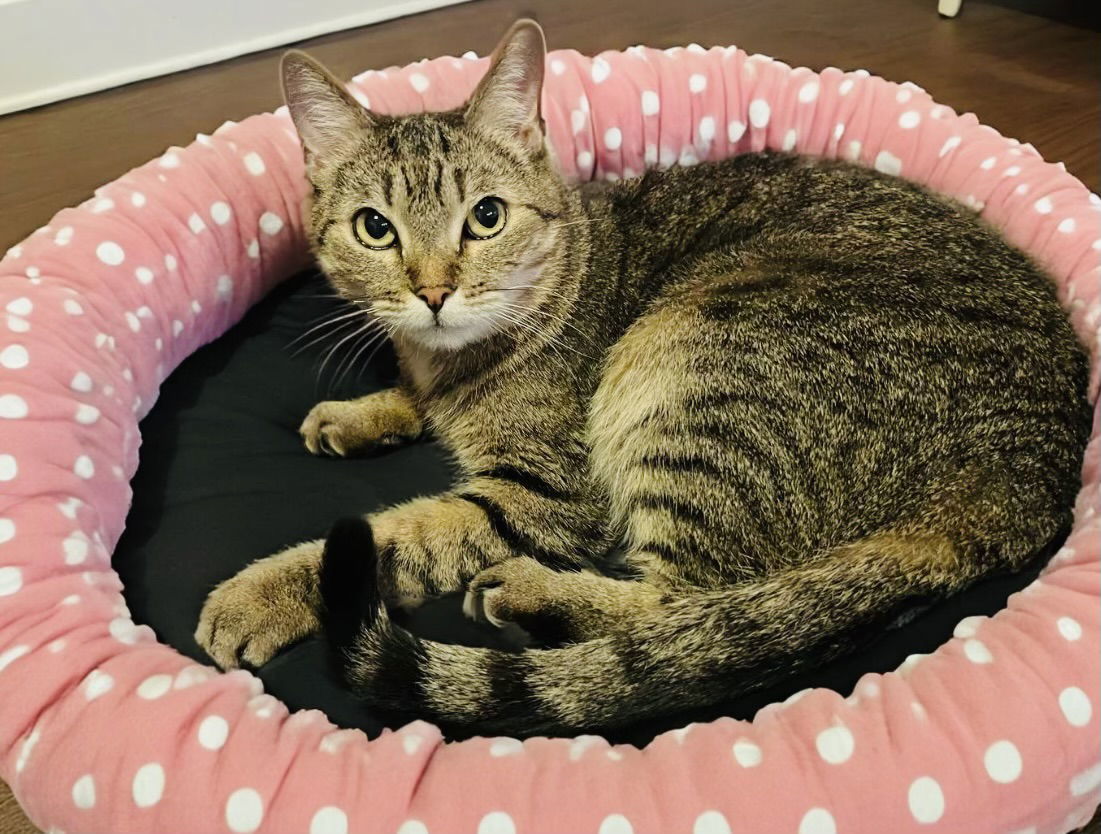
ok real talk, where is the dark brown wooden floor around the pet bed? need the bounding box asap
[0,0,1101,834]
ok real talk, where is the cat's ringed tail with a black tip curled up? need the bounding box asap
[321,520,964,735]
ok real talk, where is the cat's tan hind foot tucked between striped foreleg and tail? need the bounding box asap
[462,557,668,647]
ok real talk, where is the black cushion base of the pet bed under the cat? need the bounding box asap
[113,273,1056,745]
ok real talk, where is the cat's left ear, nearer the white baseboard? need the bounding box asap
[280,50,372,158]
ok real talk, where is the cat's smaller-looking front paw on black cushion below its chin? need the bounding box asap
[298,388,424,457]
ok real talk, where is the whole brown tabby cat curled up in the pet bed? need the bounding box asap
[196,21,1090,735]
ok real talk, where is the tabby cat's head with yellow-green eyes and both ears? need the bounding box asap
[282,21,570,350]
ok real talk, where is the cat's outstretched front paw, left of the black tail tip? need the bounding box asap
[195,542,323,669]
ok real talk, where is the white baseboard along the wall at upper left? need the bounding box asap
[0,0,469,113]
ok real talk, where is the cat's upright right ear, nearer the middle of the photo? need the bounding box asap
[467,20,546,151]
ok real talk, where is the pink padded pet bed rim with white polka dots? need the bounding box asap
[0,46,1101,834]
